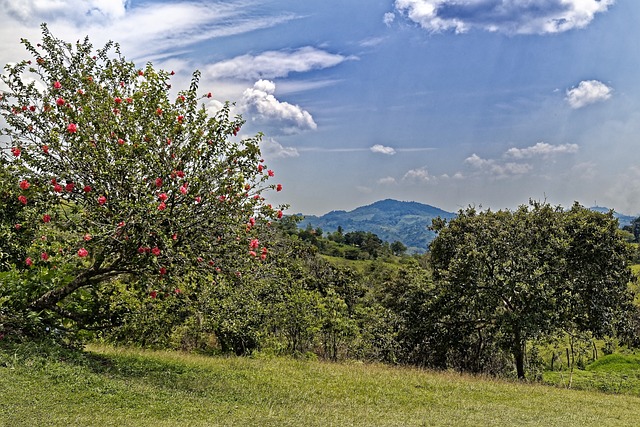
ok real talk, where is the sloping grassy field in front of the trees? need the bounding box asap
[0,346,640,427]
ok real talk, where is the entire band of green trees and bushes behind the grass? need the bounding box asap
[0,26,640,378]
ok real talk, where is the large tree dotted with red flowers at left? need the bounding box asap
[0,25,283,338]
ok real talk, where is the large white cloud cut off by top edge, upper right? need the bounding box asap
[395,0,615,34]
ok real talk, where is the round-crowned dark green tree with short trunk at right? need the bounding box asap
[431,202,631,378]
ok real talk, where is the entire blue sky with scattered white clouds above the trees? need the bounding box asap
[0,0,640,215]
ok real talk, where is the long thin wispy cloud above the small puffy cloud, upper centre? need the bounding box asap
[207,46,355,80]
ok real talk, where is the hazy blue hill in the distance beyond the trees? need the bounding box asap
[299,199,456,253]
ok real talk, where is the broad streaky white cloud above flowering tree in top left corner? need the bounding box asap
[0,0,298,63]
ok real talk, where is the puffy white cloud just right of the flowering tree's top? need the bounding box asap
[239,80,318,133]
